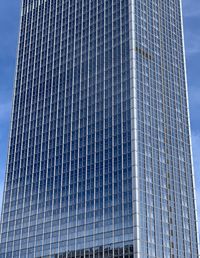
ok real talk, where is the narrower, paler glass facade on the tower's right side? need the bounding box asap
[134,0,199,258]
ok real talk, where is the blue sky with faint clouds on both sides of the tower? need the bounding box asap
[0,0,200,225]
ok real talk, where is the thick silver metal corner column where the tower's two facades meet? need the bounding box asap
[129,0,141,258]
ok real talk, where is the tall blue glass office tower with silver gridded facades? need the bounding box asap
[0,0,199,258]
